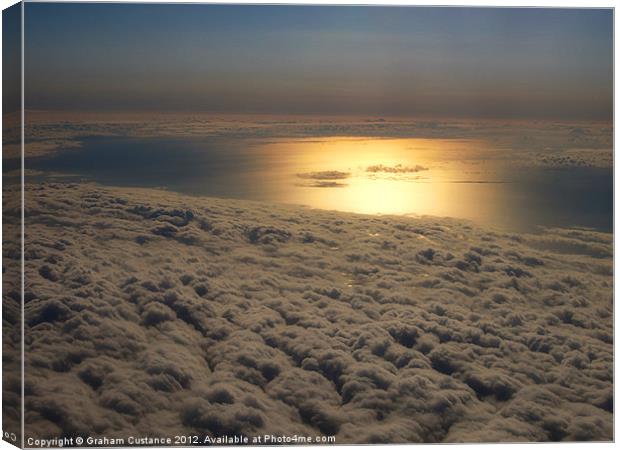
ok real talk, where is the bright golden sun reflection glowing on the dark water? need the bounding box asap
[266,138,502,223]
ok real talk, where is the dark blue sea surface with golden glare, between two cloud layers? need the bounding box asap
[21,137,613,231]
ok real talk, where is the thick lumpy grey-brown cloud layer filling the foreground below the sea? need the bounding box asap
[5,184,613,443]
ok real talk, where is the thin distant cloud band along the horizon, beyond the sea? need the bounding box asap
[12,111,613,169]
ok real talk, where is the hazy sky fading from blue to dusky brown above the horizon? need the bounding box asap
[25,3,613,119]
